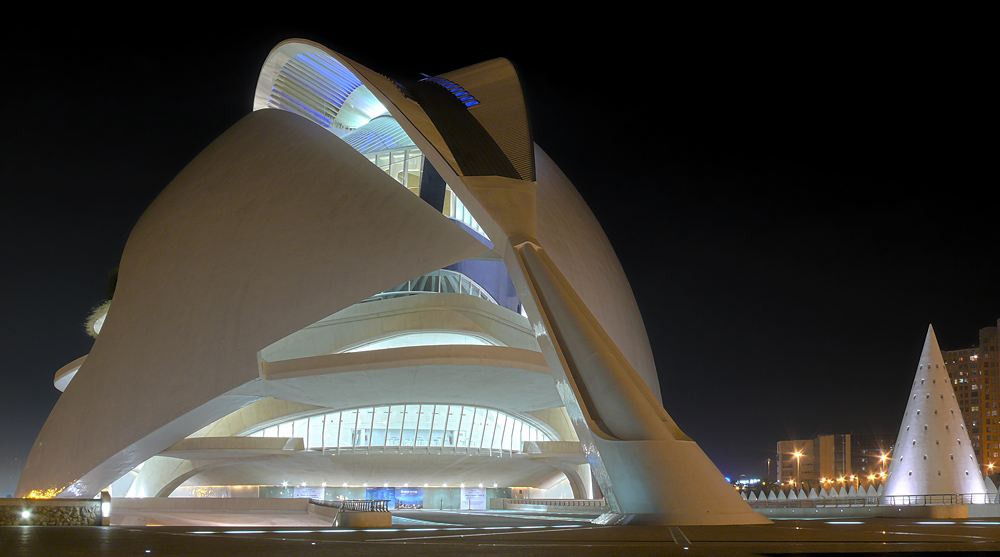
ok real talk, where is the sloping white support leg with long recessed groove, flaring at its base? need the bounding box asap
[507,242,769,525]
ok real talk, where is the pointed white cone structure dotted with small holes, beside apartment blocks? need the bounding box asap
[883,326,986,499]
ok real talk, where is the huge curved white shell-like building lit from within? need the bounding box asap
[18,40,767,524]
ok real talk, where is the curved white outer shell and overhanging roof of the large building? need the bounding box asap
[18,41,767,524]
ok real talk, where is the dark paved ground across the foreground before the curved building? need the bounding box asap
[0,511,1000,557]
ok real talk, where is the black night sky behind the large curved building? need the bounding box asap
[0,13,1000,496]
